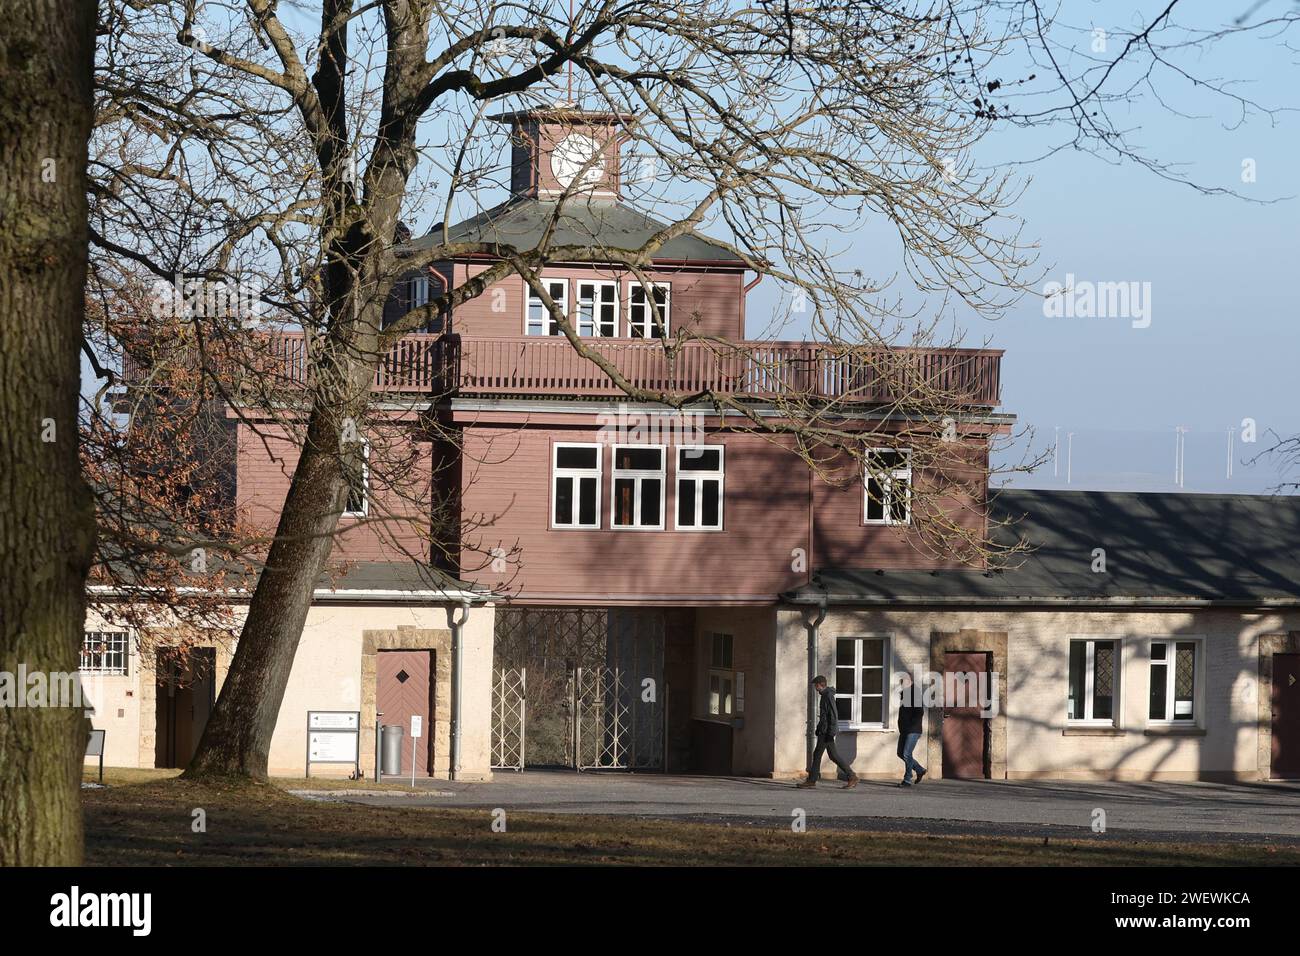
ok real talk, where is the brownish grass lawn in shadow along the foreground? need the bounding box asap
[83,770,1300,866]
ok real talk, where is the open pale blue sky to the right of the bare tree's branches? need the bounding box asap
[750,0,1300,492]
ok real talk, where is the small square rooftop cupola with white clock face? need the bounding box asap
[491,104,628,200]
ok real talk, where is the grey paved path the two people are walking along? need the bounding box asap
[299,770,1300,844]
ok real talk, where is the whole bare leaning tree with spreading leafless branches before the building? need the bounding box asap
[91,0,1294,778]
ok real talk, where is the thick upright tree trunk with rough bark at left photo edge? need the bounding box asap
[0,0,96,866]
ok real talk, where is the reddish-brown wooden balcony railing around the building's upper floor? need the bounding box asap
[127,332,1002,406]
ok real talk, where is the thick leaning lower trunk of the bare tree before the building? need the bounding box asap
[183,400,358,780]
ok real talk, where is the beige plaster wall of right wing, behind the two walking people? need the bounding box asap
[774,609,1300,780]
